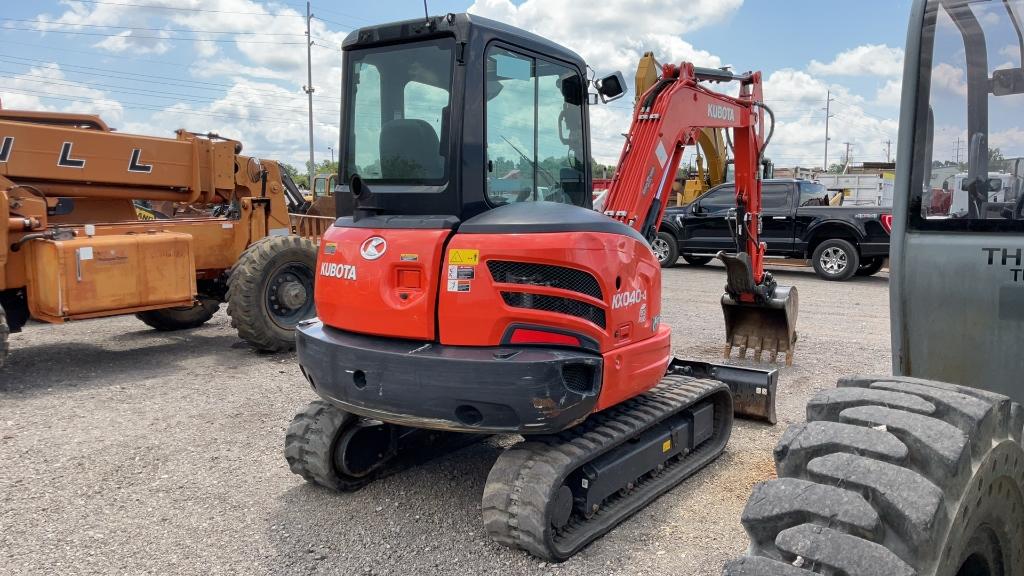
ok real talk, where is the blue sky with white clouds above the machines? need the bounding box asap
[0,0,910,165]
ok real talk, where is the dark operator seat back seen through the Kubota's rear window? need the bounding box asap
[380,119,444,179]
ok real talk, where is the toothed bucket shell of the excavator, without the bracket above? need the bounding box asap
[722,286,798,366]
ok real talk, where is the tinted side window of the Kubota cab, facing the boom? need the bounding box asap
[484,46,590,206]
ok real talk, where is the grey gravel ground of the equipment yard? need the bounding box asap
[0,261,890,575]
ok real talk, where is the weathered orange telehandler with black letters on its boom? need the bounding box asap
[0,110,319,364]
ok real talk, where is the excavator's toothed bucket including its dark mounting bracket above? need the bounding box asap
[718,253,799,366]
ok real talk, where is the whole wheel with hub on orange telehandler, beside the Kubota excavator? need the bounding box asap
[227,231,316,352]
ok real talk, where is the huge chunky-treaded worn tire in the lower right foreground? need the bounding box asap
[724,377,1024,576]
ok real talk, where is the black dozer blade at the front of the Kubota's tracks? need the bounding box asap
[669,358,778,424]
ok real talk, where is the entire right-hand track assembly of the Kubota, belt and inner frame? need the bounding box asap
[482,375,733,562]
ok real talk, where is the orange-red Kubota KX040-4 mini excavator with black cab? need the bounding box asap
[286,14,796,561]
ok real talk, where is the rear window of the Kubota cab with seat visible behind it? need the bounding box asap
[342,39,455,184]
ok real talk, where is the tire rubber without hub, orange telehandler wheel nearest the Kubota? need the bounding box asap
[227,235,316,352]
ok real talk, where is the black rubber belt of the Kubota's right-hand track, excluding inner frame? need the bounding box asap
[481,375,733,562]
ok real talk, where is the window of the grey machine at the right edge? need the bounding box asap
[911,0,1024,224]
